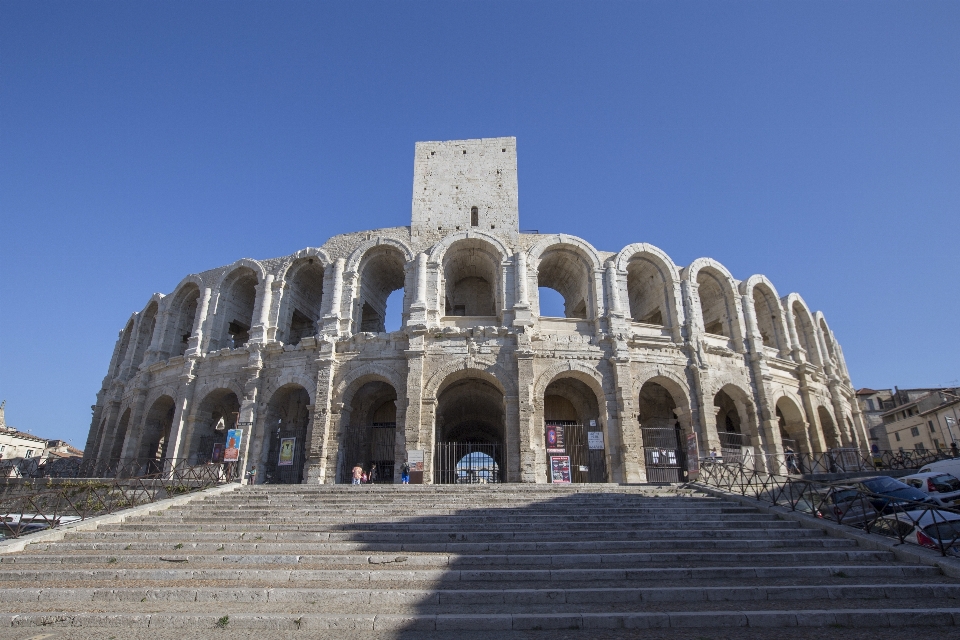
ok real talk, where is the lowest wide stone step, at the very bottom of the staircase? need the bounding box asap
[0,607,960,634]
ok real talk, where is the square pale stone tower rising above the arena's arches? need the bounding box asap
[411,138,520,236]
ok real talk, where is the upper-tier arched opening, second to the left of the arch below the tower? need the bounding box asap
[277,258,323,345]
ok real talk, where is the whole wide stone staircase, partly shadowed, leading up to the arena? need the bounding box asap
[0,485,960,637]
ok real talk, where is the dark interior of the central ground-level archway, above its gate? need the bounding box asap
[437,378,505,444]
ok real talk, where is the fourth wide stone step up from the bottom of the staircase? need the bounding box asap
[0,549,896,568]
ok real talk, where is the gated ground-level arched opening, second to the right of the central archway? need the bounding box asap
[637,381,686,482]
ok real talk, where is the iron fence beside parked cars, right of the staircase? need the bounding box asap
[695,460,960,556]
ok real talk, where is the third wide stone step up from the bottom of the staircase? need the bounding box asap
[0,562,940,587]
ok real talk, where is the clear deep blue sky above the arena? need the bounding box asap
[0,0,960,446]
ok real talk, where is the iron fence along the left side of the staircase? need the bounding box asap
[0,461,232,538]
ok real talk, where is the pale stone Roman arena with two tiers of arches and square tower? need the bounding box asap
[85,138,868,483]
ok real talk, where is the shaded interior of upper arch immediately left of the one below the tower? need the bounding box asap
[353,245,406,333]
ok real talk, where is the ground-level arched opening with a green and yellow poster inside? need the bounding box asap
[260,384,310,484]
